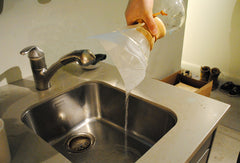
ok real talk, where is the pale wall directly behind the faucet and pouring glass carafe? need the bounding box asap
[0,0,184,86]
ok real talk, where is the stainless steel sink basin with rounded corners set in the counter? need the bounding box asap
[22,82,177,162]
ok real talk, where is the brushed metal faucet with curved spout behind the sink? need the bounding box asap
[20,46,98,90]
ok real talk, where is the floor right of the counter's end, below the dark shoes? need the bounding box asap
[208,83,240,163]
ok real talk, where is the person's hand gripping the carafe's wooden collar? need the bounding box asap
[125,0,158,36]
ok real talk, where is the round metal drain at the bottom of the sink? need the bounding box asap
[66,133,95,153]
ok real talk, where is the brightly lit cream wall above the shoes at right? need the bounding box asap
[182,0,240,81]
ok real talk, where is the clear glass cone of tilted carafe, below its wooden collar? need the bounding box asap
[93,24,150,92]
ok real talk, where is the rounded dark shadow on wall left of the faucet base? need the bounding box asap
[0,66,22,84]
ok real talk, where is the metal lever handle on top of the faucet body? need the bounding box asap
[20,46,44,58]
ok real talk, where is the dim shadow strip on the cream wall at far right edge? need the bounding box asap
[229,0,240,78]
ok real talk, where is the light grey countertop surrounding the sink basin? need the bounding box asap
[0,63,229,163]
